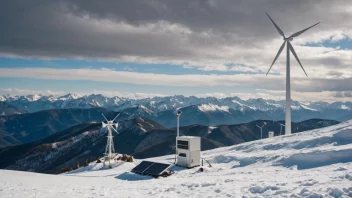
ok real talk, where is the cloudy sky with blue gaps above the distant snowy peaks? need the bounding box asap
[0,0,352,102]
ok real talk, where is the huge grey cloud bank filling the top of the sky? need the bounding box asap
[0,0,352,73]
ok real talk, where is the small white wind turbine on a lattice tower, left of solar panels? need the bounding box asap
[102,112,121,168]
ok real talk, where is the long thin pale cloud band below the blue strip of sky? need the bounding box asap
[0,68,352,92]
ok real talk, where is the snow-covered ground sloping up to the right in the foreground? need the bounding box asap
[0,121,352,198]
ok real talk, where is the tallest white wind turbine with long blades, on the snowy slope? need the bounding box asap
[266,13,320,135]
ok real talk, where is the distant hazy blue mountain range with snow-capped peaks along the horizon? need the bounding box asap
[0,93,352,128]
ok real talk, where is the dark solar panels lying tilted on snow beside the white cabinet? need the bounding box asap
[131,161,172,176]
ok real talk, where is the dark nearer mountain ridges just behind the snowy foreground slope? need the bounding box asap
[0,117,339,173]
